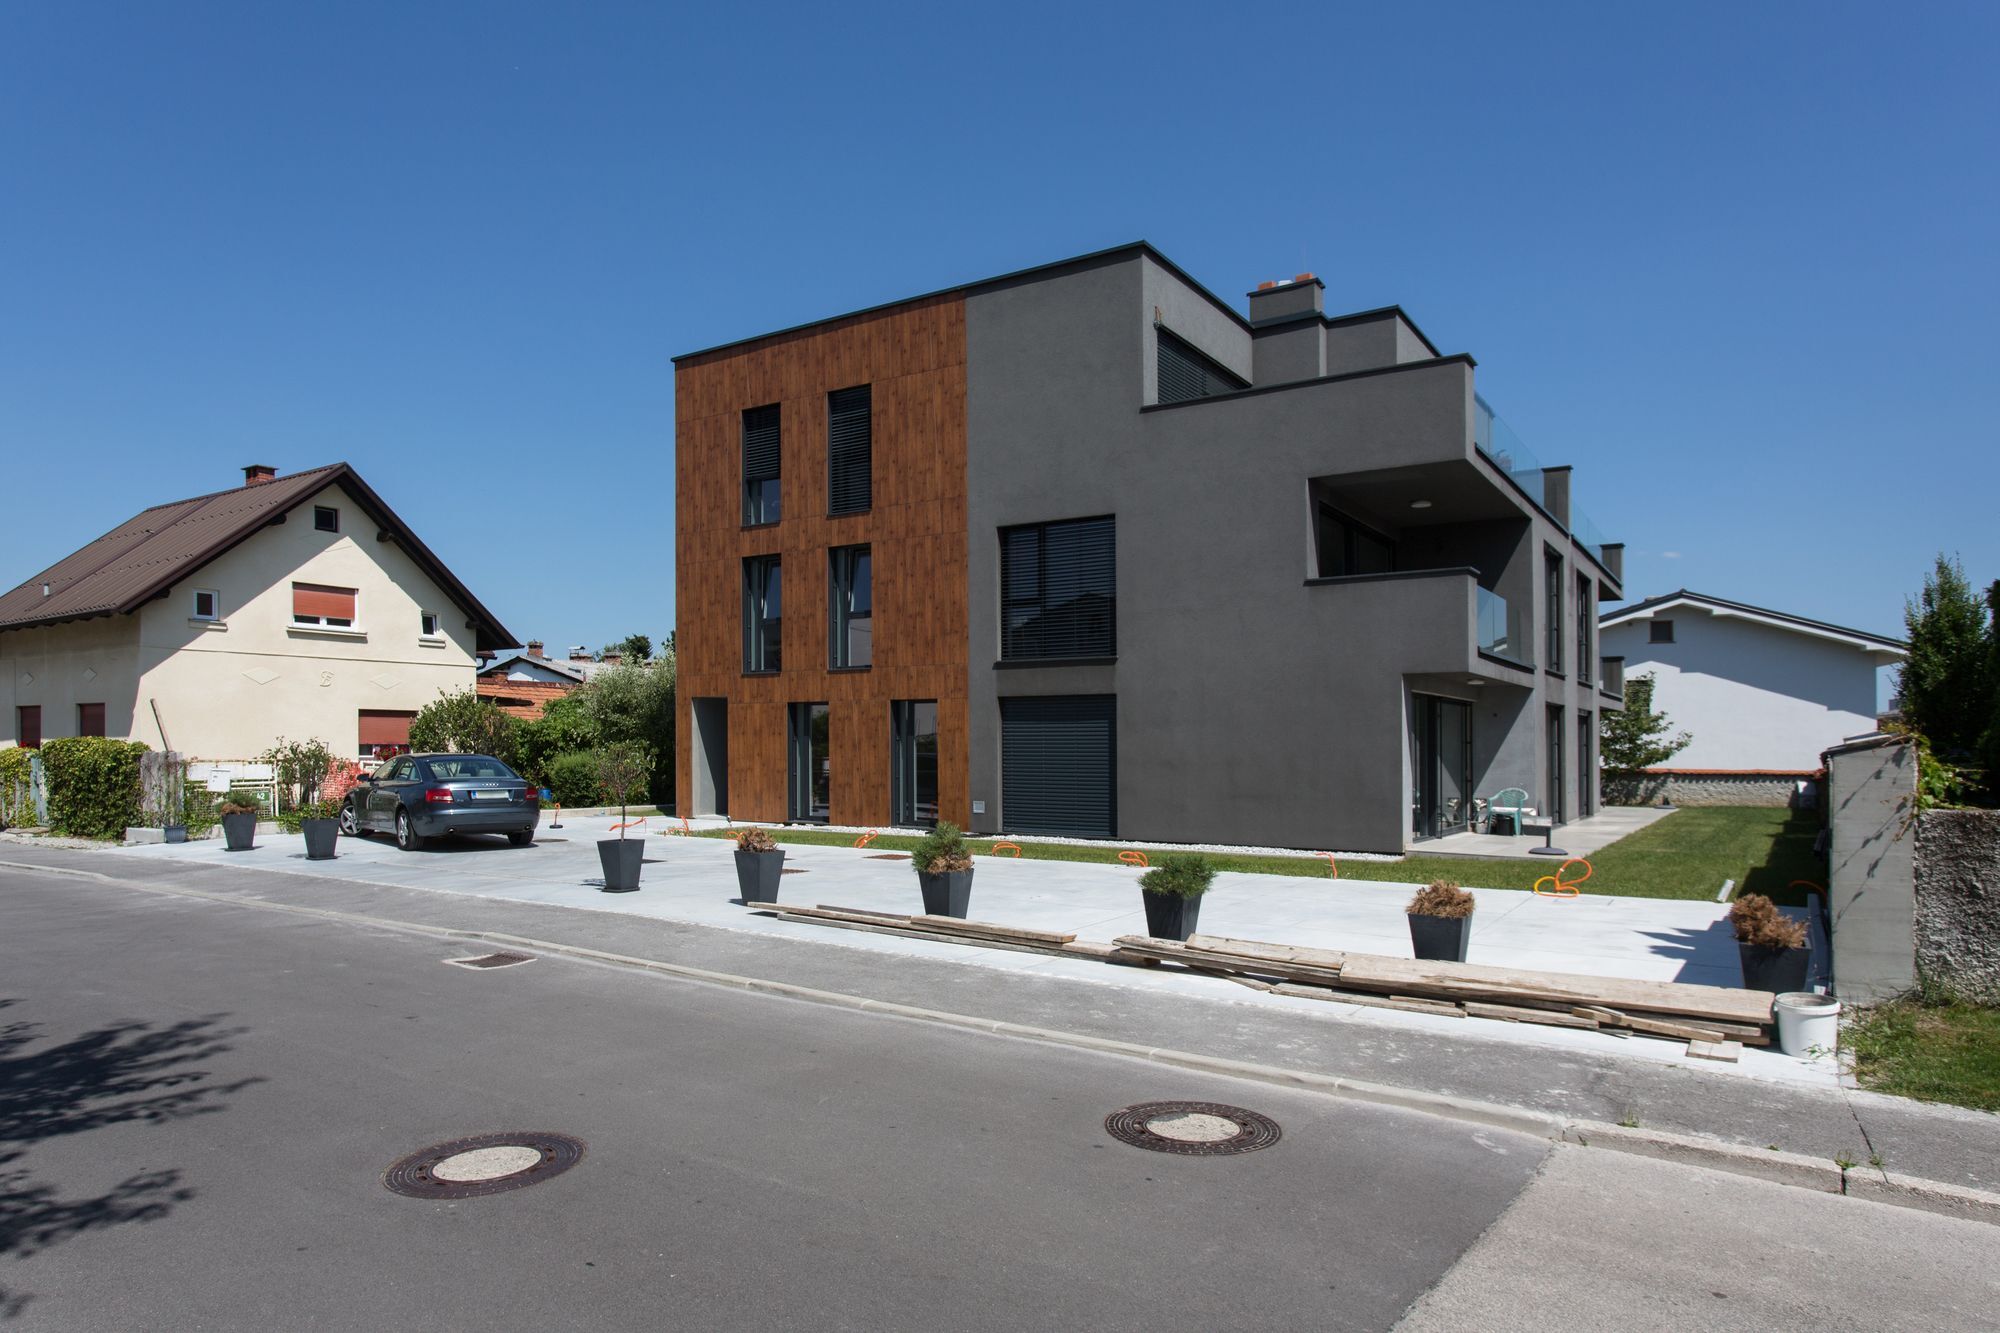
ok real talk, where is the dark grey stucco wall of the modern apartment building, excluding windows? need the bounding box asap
[966,254,1608,851]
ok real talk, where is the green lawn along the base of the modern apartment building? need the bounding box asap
[696,807,1824,903]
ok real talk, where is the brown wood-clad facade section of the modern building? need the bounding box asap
[674,294,970,827]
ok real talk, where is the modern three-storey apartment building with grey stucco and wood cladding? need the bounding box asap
[676,242,1620,851]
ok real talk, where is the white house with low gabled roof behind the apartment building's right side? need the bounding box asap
[1598,588,1908,775]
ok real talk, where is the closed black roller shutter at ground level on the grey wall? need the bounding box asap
[1000,695,1118,839]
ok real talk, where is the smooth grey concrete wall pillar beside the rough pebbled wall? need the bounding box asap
[1826,741,1916,1003]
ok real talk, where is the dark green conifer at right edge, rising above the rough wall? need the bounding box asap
[1896,554,1996,763]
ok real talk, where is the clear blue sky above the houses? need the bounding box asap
[0,0,2000,660]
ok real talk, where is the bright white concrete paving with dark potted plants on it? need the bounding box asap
[110,815,1838,1087]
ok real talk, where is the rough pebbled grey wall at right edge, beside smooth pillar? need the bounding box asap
[1916,811,2000,1005]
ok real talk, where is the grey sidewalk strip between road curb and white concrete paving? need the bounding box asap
[0,836,2000,1191]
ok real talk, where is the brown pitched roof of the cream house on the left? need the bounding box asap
[0,462,520,652]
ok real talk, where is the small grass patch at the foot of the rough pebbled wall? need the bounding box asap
[1840,999,2000,1111]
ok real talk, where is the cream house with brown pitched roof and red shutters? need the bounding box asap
[0,462,516,759]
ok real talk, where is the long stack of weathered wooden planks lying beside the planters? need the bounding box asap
[1112,935,1772,1047]
